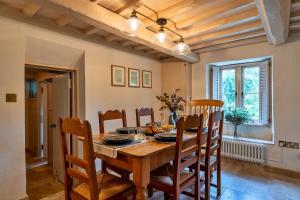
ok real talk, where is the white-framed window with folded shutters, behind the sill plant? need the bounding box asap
[210,59,271,125]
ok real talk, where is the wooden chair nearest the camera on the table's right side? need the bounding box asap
[148,115,203,200]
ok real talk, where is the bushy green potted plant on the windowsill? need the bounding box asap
[225,108,250,137]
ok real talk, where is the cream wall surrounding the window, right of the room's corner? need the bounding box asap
[192,35,300,172]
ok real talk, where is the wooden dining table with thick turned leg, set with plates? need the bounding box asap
[93,132,206,200]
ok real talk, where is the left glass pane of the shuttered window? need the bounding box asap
[221,69,236,110]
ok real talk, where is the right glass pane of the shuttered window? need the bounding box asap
[243,67,259,123]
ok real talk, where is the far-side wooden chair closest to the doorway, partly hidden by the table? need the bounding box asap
[98,110,130,180]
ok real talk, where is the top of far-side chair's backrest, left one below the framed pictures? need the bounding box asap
[98,110,127,133]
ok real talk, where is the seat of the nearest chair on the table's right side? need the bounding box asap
[151,166,193,186]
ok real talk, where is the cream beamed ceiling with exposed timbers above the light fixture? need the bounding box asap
[0,0,300,63]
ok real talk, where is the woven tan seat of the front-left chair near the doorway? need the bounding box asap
[73,173,134,200]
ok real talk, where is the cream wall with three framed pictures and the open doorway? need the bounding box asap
[0,17,161,200]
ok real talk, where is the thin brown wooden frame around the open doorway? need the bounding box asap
[24,62,79,166]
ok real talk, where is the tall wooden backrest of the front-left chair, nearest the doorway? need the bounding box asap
[60,118,99,200]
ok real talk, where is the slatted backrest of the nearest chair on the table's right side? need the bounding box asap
[173,114,203,190]
